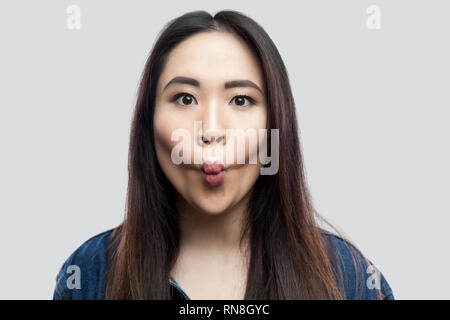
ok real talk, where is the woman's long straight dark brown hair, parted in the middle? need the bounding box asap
[105,11,376,299]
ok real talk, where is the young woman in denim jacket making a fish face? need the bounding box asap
[53,11,394,299]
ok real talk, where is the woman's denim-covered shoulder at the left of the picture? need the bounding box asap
[53,229,114,300]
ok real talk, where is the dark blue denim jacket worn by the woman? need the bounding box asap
[53,229,394,300]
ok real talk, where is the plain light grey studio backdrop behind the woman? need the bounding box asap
[0,0,450,299]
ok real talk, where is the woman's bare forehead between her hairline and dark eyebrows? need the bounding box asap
[159,31,264,87]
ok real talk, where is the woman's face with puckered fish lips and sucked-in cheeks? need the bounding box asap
[154,31,267,214]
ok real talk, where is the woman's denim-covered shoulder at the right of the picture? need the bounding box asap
[321,229,394,300]
